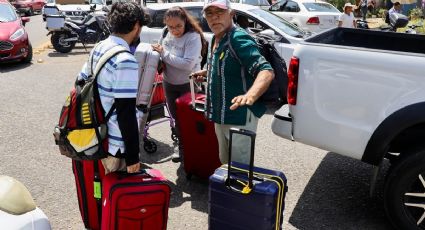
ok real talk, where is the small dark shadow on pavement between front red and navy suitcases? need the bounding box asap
[166,164,208,213]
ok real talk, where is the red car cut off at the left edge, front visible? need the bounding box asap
[0,0,32,63]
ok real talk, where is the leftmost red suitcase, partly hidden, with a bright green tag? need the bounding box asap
[72,160,105,230]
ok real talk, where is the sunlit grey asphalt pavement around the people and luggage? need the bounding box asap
[0,27,391,230]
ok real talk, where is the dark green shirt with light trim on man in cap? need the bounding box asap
[206,28,273,125]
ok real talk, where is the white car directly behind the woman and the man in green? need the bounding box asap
[140,2,309,64]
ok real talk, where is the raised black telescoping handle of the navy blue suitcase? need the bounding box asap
[226,128,256,194]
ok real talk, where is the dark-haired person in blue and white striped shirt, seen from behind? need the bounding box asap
[78,2,149,174]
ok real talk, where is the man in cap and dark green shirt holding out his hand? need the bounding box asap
[193,0,274,164]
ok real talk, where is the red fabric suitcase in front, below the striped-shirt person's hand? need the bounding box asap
[102,169,171,230]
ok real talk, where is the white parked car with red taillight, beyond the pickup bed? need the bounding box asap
[269,0,341,33]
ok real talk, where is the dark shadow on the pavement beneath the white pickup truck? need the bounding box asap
[288,153,392,230]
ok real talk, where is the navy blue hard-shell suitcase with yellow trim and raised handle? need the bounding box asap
[208,129,287,230]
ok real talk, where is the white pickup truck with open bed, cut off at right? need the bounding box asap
[272,28,425,229]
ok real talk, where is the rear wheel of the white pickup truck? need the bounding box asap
[384,149,425,229]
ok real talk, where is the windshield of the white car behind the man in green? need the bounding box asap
[249,8,305,37]
